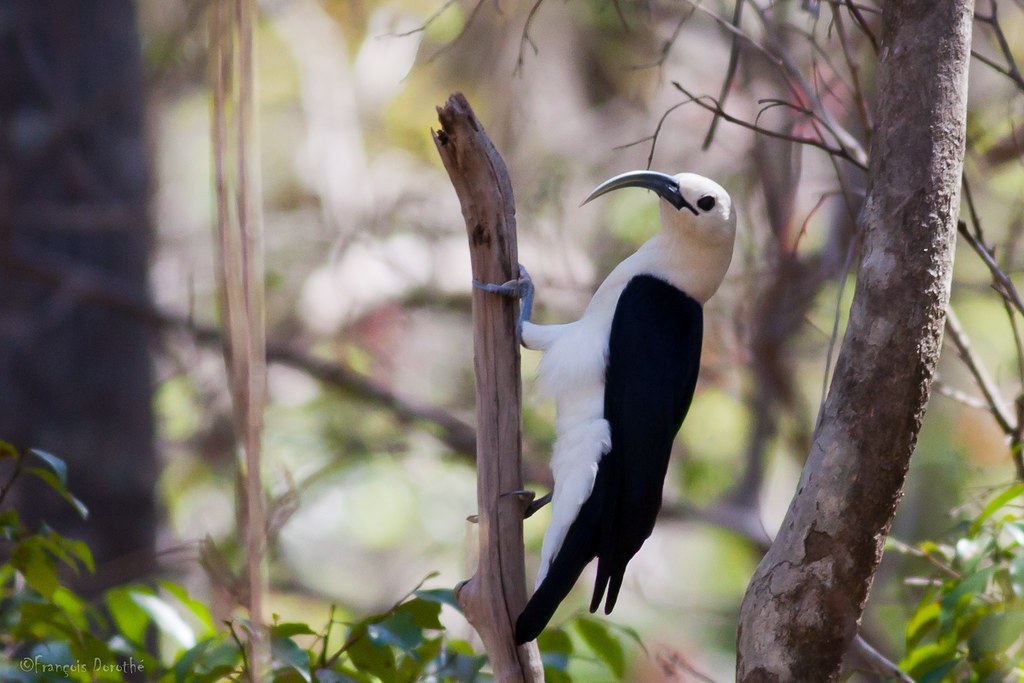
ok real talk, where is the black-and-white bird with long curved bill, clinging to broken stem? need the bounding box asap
[477,170,736,644]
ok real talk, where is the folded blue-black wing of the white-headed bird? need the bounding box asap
[591,274,703,613]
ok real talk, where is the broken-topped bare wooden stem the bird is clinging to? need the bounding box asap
[434,93,544,682]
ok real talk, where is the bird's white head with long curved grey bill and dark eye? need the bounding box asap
[583,171,736,301]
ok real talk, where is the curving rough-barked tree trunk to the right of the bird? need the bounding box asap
[737,0,973,683]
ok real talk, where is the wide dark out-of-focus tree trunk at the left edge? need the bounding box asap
[0,0,156,583]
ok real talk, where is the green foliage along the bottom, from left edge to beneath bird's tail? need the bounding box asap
[6,441,625,683]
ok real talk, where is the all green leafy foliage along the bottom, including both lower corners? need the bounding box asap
[0,441,1024,683]
